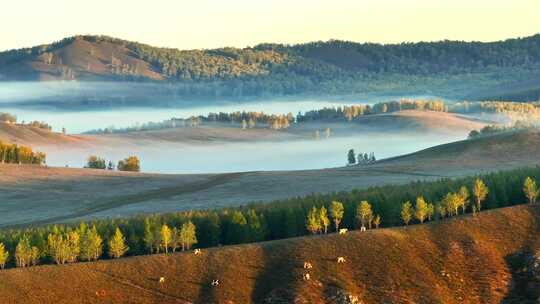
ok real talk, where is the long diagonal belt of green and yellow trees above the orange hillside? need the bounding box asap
[0,167,540,266]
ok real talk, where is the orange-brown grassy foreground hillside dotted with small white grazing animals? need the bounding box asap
[0,206,540,303]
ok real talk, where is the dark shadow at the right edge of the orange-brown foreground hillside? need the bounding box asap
[502,206,540,304]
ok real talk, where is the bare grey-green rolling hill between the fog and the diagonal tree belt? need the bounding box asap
[0,126,540,226]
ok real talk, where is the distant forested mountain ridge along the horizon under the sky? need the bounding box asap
[0,34,540,98]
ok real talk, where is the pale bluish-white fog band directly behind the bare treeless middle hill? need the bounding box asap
[41,132,464,173]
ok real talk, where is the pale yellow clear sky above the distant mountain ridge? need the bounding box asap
[0,0,540,50]
